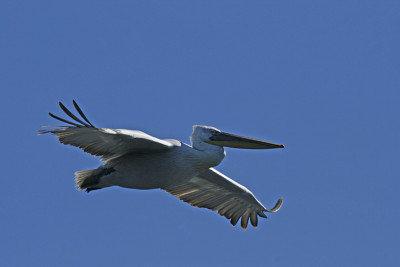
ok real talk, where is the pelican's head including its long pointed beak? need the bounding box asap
[191,125,285,149]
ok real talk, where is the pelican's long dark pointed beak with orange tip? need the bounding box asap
[205,132,285,149]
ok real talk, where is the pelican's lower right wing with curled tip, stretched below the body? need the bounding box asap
[163,168,283,229]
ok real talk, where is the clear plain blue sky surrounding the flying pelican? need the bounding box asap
[0,0,400,267]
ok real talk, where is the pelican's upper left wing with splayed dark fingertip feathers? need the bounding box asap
[38,101,177,161]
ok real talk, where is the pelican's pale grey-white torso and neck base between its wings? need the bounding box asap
[99,143,225,189]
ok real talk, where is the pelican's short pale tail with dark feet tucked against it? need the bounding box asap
[75,167,114,192]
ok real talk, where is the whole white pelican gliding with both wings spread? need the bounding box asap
[38,100,284,229]
